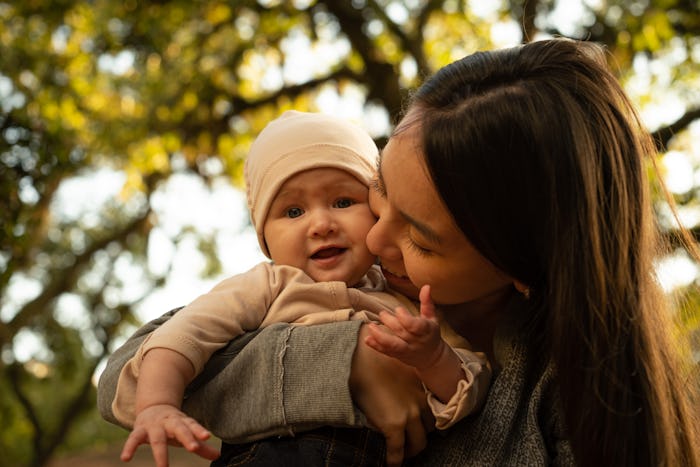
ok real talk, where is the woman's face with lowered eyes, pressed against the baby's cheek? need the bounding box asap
[367,119,513,305]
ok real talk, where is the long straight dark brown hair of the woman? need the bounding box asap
[410,39,700,466]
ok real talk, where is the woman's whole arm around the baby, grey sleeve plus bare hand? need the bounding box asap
[98,310,432,464]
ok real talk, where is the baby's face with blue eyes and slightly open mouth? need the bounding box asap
[263,168,375,286]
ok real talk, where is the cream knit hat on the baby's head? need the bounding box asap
[244,110,378,258]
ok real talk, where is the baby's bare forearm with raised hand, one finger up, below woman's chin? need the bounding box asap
[365,285,464,403]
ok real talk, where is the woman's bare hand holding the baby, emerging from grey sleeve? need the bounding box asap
[350,325,435,466]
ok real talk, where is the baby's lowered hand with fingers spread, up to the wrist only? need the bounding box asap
[121,404,219,467]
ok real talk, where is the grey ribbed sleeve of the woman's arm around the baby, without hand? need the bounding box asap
[98,310,366,442]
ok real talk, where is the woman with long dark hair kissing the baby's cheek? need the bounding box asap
[101,40,700,466]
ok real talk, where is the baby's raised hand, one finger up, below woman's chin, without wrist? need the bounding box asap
[365,285,443,370]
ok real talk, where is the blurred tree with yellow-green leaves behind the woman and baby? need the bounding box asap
[0,0,700,466]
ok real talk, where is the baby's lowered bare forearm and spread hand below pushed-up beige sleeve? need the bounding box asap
[121,348,219,467]
